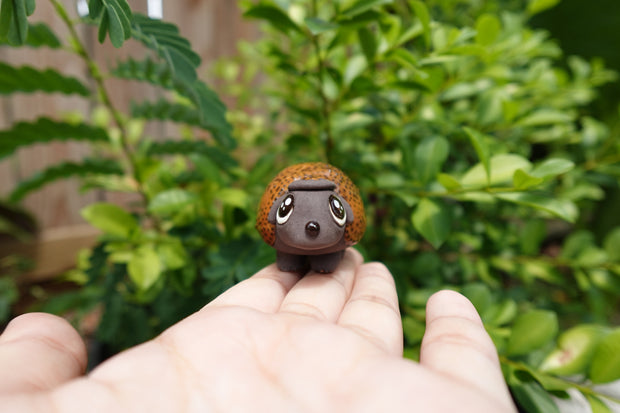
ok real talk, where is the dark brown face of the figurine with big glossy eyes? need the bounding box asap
[269,180,353,254]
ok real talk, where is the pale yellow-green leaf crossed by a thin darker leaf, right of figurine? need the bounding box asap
[461,154,532,187]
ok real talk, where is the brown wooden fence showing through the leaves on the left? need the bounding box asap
[0,0,258,276]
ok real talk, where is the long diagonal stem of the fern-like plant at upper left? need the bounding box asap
[50,0,156,211]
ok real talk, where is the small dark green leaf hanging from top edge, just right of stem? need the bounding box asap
[88,0,132,48]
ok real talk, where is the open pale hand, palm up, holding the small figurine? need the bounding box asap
[0,249,516,413]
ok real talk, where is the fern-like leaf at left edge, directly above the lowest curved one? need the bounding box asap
[0,117,109,159]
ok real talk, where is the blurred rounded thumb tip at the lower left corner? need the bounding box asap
[0,313,87,394]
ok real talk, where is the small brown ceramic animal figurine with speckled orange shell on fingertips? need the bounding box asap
[256,162,366,274]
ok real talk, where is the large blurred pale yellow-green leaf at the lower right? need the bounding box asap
[540,324,606,376]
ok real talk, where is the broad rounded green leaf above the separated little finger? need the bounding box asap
[411,198,452,248]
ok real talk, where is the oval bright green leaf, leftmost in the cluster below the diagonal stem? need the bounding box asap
[81,202,138,238]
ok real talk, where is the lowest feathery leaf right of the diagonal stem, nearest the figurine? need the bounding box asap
[147,140,237,171]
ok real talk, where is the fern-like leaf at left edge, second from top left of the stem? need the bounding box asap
[0,62,90,96]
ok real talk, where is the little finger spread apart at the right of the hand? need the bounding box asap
[420,290,512,406]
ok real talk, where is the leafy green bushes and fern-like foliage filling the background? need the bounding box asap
[0,0,620,412]
